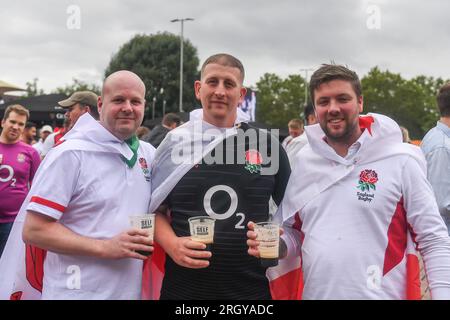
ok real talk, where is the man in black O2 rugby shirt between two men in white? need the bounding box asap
[150,54,290,299]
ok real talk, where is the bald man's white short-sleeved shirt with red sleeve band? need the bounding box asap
[27,115,154,299]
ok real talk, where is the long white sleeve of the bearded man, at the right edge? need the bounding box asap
[402,157,450,300]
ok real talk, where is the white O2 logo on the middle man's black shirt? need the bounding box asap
[203,184,245,229]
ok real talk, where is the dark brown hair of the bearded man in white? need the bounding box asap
[309,64,362,105]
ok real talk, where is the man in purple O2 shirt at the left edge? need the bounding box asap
[0,105,41,256]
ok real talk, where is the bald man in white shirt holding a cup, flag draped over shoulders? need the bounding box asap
[0,71,154,299]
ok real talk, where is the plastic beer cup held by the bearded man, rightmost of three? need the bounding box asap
[255,222,280,267]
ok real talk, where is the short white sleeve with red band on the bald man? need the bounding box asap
[27,150,81,220]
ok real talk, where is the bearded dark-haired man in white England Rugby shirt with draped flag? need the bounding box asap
[248,65,450,299]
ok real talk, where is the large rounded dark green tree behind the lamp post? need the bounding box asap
[105,32,199,118]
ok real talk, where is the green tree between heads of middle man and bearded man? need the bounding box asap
[256,73,306,128]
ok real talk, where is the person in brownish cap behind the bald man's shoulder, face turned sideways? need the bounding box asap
[41,91,99,158]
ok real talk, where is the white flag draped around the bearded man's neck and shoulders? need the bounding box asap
[275,113,426,225]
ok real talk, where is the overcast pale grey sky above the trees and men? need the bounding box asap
[0,0,450,92]
